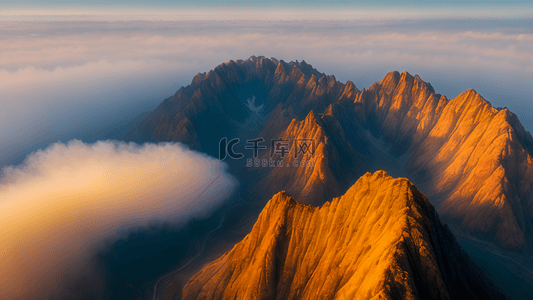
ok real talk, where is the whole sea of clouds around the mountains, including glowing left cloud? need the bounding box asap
[0,15,533,299]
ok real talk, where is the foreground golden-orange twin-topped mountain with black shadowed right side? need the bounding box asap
[183,171,505,299]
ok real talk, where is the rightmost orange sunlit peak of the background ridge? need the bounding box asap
[412,90,533,247]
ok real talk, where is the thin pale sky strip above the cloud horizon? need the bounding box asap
[0,0,533,21]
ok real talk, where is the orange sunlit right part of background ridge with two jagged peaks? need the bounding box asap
[348,72,533,247]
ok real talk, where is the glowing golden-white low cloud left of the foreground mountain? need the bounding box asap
[0,140,237,299]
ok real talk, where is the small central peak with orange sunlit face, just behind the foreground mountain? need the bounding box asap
[255,111,362,205]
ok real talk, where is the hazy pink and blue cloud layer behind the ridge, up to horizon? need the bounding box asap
[0,18,533,166]
